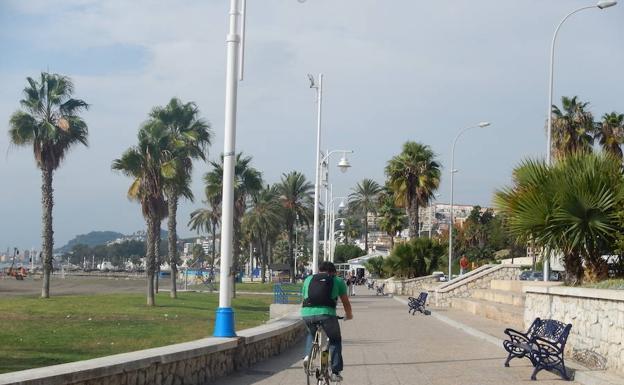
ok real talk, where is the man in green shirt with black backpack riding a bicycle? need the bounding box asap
[301,261,353,382]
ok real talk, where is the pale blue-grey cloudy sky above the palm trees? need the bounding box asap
[0,0,624,250]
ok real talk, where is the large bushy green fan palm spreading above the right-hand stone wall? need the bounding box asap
[495,152,624,285]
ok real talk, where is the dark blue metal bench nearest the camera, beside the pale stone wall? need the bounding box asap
[503,318,572,381]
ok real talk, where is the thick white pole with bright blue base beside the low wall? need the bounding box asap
[214,0,240,337]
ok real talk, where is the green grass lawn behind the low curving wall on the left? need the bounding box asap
[0,292,272,373]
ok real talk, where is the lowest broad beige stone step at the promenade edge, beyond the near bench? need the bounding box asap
[451,298,524,330]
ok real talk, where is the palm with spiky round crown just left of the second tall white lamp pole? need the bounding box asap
[277,171,314,282]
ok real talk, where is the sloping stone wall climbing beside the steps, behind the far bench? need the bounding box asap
[432,264,521,307]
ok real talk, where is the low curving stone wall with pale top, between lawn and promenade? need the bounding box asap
[0,318,305,385]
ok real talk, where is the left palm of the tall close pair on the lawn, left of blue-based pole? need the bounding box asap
[112,120,180,306]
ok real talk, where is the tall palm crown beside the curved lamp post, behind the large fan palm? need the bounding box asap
[552,96,595,157]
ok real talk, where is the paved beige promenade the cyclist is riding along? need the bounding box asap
[219,288,576,385]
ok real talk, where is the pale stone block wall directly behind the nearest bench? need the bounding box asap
[524,286,624,374]
